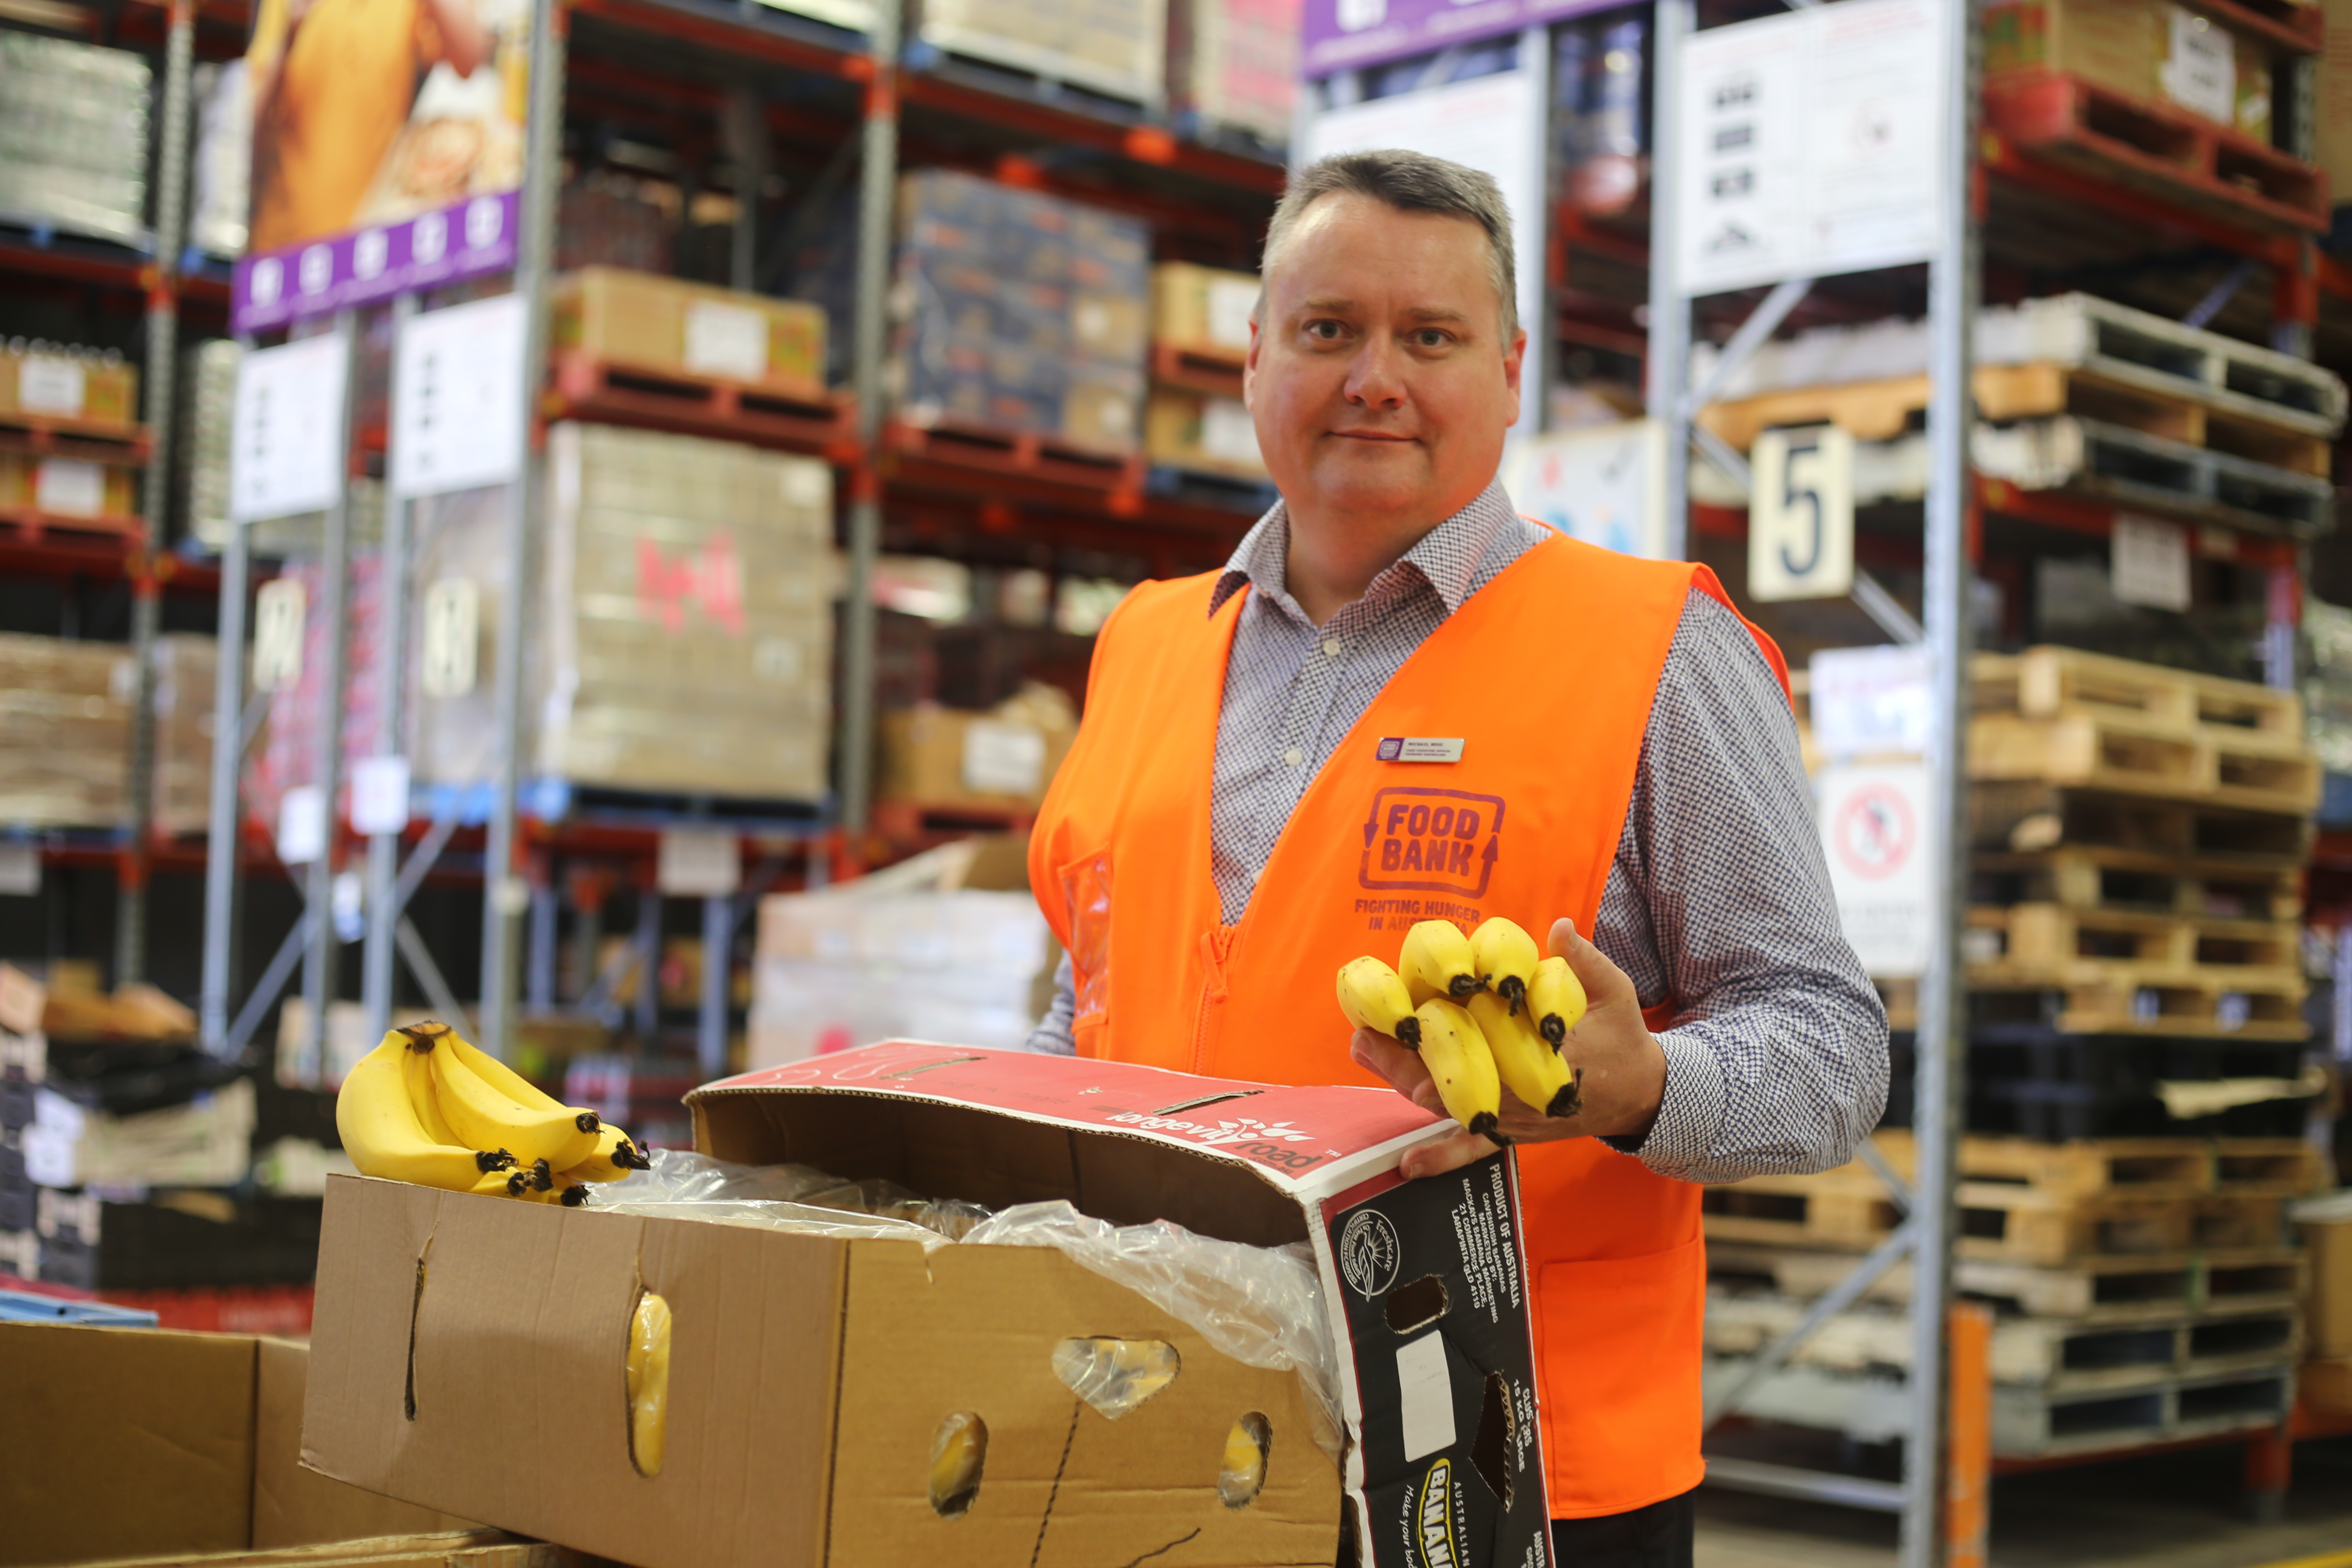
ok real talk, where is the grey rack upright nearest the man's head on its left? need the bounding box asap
[835,0,901,835]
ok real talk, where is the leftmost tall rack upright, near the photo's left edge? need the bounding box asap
[115,0,195,985]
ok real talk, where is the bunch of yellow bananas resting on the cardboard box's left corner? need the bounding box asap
[334,1020,652,1206]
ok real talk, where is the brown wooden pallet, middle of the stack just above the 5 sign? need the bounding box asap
[1698,364,2331,477]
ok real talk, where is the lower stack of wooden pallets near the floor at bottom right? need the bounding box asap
[1705,1133,2321,1458]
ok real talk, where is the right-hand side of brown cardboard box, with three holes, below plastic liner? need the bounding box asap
[828,1241,1341,1568]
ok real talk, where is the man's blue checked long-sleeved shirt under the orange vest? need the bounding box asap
[1030,484,1886,1182]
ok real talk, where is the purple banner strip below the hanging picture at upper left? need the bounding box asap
[228,190,522,331]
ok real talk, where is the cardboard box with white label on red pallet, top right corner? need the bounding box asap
[1985,0,2272,146]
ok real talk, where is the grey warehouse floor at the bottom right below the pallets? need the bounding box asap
[1698,1439,2352,1568]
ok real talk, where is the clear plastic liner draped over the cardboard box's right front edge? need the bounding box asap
[965,1201,1343,1462]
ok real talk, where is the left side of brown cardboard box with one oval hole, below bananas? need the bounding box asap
[303,1176,847,1568]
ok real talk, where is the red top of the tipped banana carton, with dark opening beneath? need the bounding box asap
[687,1041,1451,1246]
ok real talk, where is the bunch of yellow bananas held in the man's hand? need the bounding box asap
[1338,915,1585,1142]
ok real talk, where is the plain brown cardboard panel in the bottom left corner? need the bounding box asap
[0,1323,254,1563]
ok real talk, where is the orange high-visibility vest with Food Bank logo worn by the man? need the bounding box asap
[1030,538,1788,1519]
